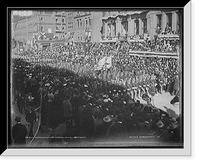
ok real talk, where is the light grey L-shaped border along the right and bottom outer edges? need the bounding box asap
[1,1,192,157]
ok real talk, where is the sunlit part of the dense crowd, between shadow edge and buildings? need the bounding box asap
[13,42,179,93]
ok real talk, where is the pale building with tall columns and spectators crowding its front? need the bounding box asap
[101,10,180,42]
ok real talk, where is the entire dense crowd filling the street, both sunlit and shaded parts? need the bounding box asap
[12,42,180,146]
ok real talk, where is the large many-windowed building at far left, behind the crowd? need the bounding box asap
[13,11,66,45]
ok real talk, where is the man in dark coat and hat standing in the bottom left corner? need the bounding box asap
[12,117,27,144]
